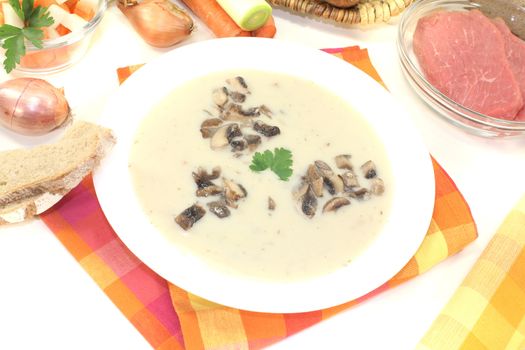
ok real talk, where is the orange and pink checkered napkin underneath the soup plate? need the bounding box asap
[41,47,477,349]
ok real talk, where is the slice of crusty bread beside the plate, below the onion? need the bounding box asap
[0,120,115,224]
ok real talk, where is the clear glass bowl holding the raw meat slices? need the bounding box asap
[397,0,525,137]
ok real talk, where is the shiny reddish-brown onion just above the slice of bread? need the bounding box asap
[0,78,70,135]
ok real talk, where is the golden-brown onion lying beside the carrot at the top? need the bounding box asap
[118,0,193,47]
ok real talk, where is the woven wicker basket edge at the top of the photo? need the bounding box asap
[268,0,415,26]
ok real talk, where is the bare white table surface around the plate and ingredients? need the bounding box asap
[0,5,525,350]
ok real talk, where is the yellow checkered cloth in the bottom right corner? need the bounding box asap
[417,196,525,350]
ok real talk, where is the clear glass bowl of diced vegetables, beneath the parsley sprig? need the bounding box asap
[1,0,107,74]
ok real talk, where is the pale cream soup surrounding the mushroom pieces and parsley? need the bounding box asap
[129,70,393,281]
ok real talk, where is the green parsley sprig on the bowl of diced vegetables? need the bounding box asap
[0,0,55,73]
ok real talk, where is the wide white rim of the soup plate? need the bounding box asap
[93,38,435,313]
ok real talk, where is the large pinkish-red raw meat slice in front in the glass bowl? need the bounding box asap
[413,10,523,120]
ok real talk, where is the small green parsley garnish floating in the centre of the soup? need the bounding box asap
[250,147,293,181]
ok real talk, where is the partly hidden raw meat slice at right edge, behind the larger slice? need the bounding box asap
[493,18,525,121]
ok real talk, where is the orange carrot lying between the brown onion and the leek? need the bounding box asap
[182,0,251,38]
